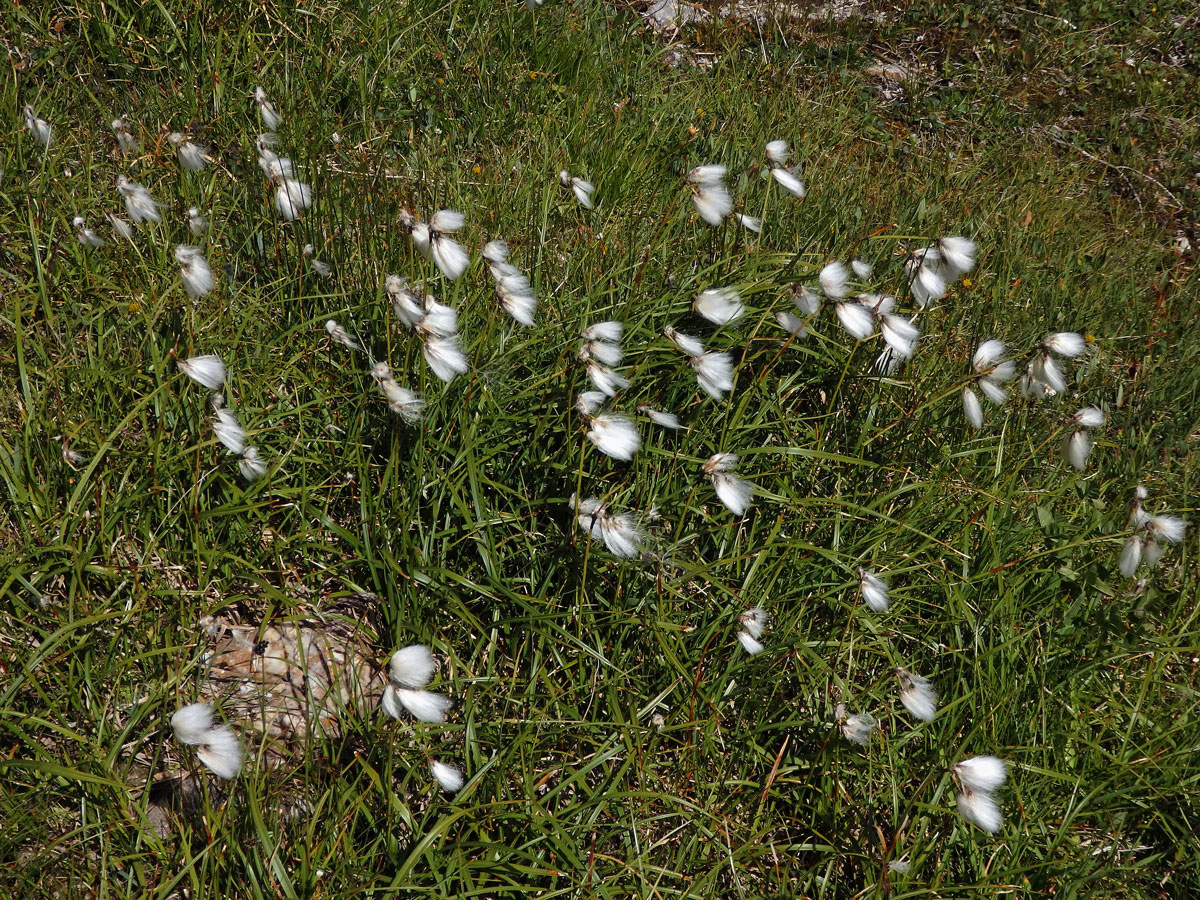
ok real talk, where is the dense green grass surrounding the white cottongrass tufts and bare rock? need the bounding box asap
[0,0,1200,898]
